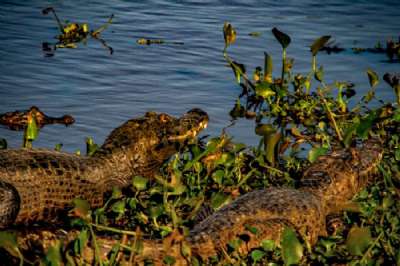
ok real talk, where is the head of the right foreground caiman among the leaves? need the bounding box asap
[299,138,383,213]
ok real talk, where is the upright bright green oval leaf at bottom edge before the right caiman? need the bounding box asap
[281,227,303,265]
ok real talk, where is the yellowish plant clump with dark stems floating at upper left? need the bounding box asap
[42,7,114,56]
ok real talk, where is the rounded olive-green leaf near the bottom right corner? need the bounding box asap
[346,226,373,256]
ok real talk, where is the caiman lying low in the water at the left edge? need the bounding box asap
[0,106,75,130]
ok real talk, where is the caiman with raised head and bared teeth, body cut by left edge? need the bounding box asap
[0,109,208,228]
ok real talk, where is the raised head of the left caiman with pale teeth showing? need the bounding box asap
[97,109,208,175]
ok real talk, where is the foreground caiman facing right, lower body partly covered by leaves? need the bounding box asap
[7,139,383,265]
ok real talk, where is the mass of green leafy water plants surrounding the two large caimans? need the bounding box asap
[0,19,400,265]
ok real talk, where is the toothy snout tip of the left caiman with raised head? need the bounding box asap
[168,108,208,141]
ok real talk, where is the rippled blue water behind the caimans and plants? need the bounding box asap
[0,0,400,151]
